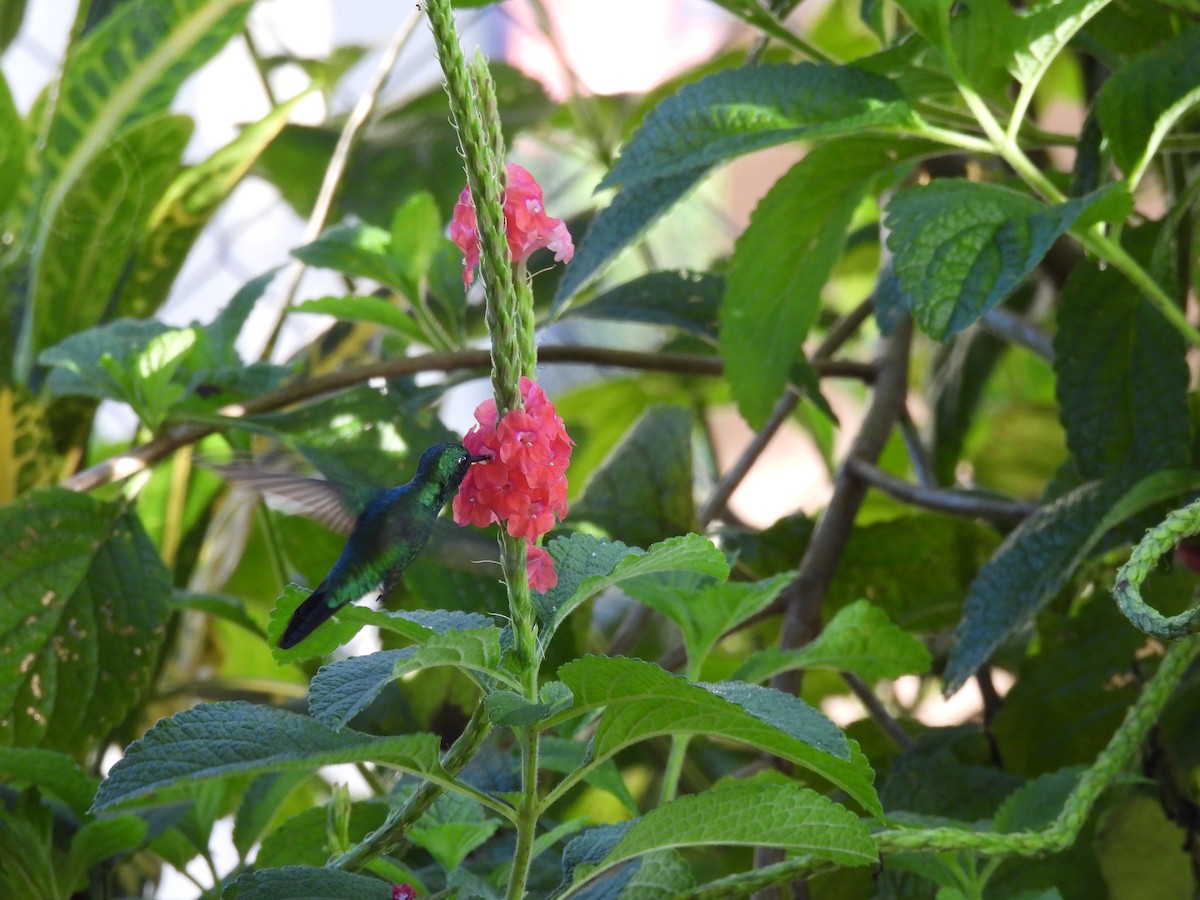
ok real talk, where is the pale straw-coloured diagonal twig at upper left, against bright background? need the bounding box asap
[263,8,421,356]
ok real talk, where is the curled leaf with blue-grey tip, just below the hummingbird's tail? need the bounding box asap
[308,626,508,728]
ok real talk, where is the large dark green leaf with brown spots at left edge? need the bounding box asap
[0,488,170,754]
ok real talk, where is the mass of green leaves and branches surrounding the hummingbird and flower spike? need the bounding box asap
[0,0,1200,899]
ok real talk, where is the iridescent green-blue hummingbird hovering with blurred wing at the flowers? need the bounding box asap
[218,443,490,650]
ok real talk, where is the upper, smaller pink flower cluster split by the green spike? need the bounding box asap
[450,162,575,288]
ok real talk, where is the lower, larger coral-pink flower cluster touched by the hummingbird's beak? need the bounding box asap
[454,378,575,592]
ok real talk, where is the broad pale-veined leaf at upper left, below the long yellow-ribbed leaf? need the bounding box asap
[29,115,192,353]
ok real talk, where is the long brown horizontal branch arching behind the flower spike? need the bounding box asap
[61,344,875,491]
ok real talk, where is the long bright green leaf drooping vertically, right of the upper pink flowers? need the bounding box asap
[721,136,934,427]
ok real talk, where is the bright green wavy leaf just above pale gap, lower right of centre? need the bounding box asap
[733,600,932,684]
